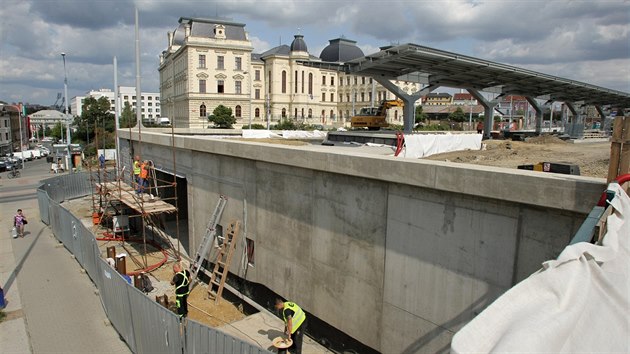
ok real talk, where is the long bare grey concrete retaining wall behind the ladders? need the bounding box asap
[120,131,605,353]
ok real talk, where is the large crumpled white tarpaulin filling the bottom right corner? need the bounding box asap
[451,183,630,353]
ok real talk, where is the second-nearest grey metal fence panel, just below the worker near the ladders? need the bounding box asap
[128,286,183,354]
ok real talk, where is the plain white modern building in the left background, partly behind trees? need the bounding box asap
[70,86,161,122]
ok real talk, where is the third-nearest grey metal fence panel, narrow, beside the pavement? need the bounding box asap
[97,259,136,353]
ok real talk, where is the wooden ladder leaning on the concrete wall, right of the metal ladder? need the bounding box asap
[208,221,241,304]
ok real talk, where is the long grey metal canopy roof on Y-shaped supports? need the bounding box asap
[304,44,630,108]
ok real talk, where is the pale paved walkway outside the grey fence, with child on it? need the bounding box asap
[0,160,130,353]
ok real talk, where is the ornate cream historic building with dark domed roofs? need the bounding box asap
[158,17,420,128]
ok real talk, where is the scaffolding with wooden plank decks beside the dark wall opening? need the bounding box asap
[87,120,181,275]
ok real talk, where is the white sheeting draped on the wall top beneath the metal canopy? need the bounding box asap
[402,134,482,159]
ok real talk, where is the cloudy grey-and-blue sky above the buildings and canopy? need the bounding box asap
[0,0,630,105]
